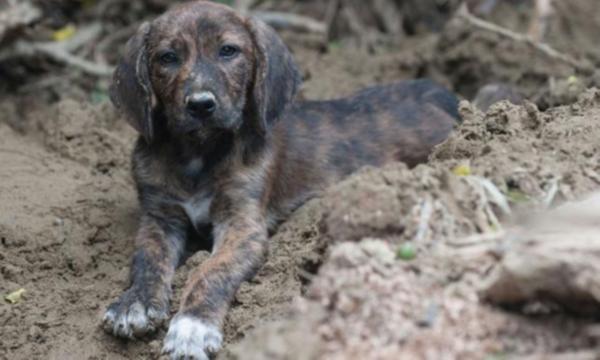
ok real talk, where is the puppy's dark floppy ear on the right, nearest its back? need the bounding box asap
[248,18,301,135]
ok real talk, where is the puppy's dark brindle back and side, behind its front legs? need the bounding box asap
[272,80,460,218]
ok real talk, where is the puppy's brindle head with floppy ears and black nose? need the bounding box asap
[111,1,300,142]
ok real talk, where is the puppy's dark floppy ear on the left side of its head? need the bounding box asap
[110,22,156,142]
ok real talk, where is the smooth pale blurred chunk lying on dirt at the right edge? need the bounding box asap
[482,192,600,316]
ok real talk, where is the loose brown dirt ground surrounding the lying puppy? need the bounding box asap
[0,0,600,360]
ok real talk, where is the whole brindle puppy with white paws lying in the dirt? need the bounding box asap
[104,1,458,359]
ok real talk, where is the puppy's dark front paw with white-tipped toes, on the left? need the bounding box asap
[102,288,168,339]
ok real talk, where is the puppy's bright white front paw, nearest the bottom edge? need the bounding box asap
[163,314,223,360]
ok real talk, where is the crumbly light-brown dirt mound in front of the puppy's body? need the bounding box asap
[229,90,600,359]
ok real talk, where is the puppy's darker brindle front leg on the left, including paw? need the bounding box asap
[103,216,185,338]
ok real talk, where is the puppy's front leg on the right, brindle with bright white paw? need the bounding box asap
[163,199,267,359]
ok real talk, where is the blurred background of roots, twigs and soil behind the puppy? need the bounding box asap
[0,0,600,108]
